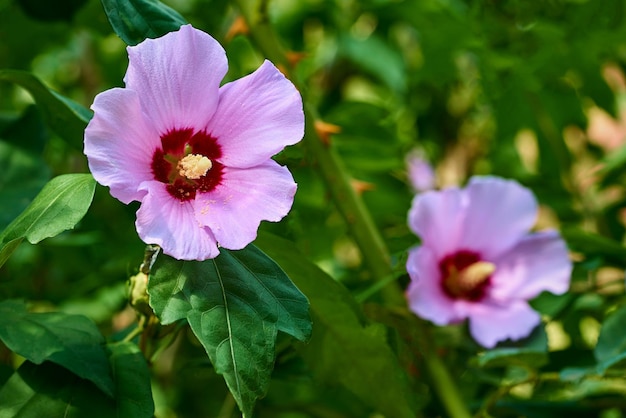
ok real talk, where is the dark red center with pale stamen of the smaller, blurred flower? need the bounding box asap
[439,250,495,302]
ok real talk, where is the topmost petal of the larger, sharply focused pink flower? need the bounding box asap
[124,25,228,134]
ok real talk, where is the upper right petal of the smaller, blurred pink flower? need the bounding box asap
[458,177,538,259]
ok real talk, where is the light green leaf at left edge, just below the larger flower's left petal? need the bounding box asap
[0,174,96,267]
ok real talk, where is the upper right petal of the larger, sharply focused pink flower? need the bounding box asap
[208,61,304,168]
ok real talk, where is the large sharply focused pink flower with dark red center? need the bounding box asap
[85,25,304,260]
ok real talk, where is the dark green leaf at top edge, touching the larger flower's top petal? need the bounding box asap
[102,0,187,45]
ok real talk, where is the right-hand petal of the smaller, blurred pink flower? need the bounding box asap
[489,231,572,301]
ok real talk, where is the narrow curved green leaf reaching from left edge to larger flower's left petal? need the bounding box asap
[0,70,92,149]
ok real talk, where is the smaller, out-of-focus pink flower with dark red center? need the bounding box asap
[407,177,572,348]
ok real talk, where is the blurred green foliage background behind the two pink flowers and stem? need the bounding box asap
[0,0,626,417]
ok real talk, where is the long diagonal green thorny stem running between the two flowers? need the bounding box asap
[235,0,471,418]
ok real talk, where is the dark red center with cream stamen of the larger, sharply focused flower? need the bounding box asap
[152,128,224,202]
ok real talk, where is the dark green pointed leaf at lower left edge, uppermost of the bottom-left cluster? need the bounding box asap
[0,301,115,397]
